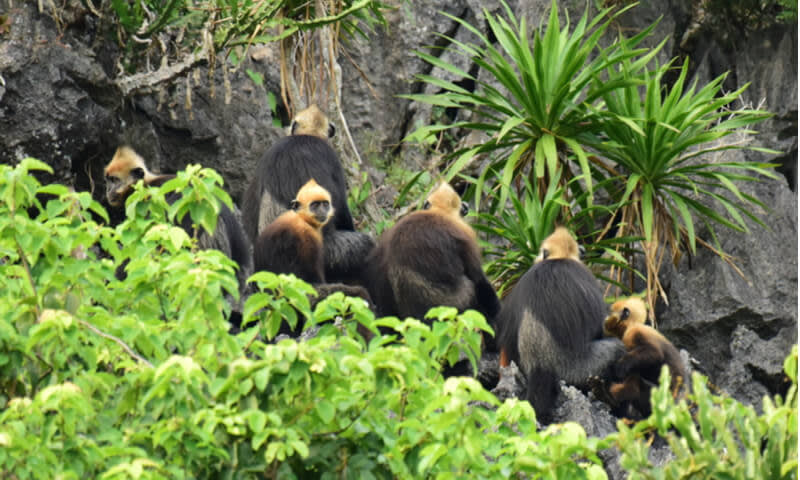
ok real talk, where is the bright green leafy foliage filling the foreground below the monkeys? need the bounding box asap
[0,159,797,479]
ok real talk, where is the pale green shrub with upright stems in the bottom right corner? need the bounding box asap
[612,346,798,480]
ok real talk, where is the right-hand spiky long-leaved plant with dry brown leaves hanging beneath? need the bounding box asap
[593,55,777,316]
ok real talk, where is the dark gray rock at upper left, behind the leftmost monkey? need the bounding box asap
[0,0,282,200]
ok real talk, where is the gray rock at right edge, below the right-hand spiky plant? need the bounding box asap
[659,164,797,407]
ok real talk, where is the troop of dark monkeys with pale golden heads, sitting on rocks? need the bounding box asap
[105,106,689,421]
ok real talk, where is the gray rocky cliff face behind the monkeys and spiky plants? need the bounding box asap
[0,0,798,438]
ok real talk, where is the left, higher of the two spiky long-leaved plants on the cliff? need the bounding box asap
[407,2,660,212]
